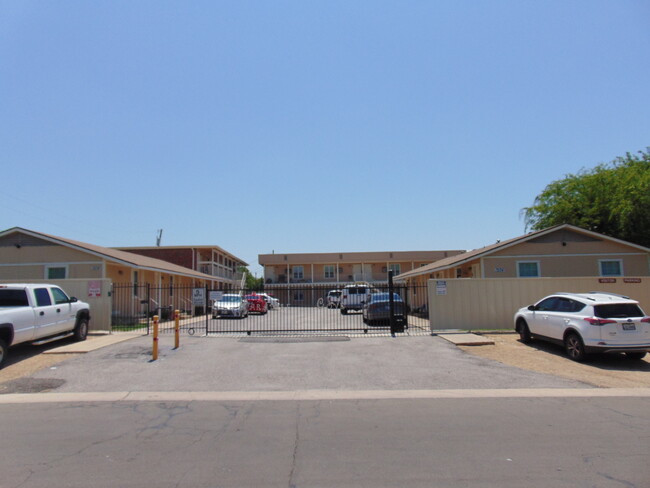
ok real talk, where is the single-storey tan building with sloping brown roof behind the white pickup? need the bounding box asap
[0,227,228,330]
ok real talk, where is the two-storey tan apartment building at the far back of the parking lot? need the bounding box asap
[259,250,463,289]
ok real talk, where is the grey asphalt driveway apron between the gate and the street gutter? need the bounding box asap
[8,336,591,393]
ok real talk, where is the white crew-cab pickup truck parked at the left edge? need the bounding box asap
[0,284,90,368]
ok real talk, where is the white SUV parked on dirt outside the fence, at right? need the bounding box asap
[514,292,650,361]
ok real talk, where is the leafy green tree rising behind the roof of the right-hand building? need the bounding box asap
[522,148,650,247]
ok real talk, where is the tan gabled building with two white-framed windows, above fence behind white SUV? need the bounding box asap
[397,224,650,284]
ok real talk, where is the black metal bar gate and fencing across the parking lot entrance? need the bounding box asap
[112,283,430,336]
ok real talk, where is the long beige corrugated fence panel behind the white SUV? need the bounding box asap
[428,276,650,330]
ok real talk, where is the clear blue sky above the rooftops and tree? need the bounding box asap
[0,0,650,273]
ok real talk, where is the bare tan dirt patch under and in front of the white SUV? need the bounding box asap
[459,333,650,388]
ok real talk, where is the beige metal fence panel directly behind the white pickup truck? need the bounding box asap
[2,279,112,331]
